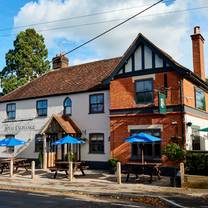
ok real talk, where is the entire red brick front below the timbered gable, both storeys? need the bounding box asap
[110,72,184,162]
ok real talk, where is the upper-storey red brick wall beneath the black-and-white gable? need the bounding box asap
[110,72,181,110]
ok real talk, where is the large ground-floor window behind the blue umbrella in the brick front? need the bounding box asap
[131,129,161,161]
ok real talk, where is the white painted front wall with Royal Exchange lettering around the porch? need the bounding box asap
[0,91,110,161]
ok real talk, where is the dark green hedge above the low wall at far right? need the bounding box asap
[185,151,208,176]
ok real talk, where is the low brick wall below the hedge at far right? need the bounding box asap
[183,174,208,189]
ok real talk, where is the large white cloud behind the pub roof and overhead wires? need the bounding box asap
[14,0,193,67]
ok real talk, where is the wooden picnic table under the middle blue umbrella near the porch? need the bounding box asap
[49,161,87,178]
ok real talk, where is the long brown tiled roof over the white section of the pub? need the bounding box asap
[0,57,121,102]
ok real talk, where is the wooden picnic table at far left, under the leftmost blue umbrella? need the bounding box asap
[0,158,30,174]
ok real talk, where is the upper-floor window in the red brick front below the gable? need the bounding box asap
[136,79,154,104]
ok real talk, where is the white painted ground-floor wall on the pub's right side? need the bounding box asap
[185,114,208,151]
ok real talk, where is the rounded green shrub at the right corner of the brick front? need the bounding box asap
[163,143,185,162]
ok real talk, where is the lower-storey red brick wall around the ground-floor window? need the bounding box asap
[110,113,183,163]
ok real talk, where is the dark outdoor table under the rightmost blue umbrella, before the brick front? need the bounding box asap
[126,162,162,183]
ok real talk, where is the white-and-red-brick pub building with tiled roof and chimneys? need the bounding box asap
[0,26,208,168]
